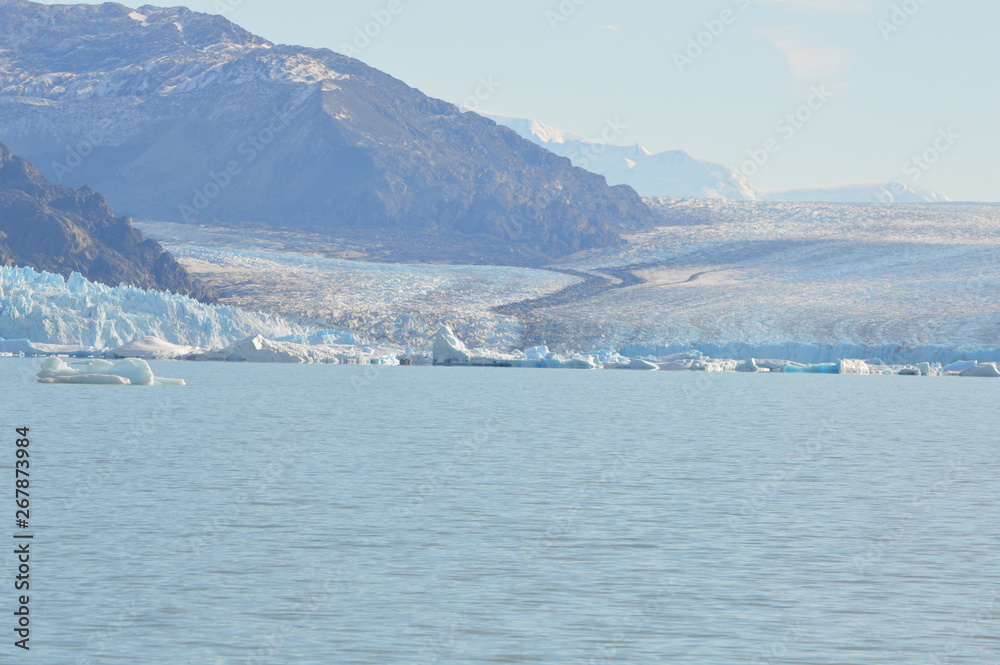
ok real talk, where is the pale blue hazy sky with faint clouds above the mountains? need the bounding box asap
[39,0,1000,201]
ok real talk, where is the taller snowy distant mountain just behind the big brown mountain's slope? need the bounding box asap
[479,111,760,201]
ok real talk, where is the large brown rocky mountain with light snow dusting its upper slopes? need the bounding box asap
[0,0,653,262]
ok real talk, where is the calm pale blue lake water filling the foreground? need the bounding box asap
[0,360,1000,665]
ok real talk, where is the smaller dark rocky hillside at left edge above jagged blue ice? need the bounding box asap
[0,145,213,302]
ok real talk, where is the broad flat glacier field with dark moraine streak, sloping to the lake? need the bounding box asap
[138,199,1000,371]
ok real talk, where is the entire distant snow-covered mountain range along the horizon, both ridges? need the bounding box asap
[478,111,950,203]
